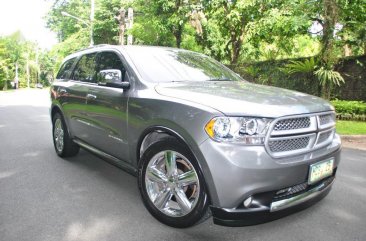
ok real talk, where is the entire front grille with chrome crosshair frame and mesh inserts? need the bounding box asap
[266,112,335,158]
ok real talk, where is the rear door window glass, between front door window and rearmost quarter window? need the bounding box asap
[73,53,96,83]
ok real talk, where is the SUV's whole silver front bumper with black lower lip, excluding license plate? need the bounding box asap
[200,135,341,226]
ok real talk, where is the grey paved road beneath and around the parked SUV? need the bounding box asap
[0,90,366,241]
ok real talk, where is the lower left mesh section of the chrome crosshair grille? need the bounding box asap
[268,136,310,152]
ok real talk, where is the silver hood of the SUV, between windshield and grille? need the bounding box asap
[155,81,334,118]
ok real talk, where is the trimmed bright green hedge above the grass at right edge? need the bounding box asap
[331,100,366,121]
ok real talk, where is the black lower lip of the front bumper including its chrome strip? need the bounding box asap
[210,173,334,227]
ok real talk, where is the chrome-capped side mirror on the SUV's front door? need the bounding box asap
[97,69,130,89]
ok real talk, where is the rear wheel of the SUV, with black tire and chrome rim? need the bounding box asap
[52,113,80,157]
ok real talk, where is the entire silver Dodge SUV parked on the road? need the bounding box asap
[51,45,341,227]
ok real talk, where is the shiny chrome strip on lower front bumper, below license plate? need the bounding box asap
[270,179,334,212]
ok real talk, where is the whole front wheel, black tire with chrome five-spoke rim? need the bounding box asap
[138,137,208,228]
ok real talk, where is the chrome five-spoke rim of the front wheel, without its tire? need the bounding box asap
[145,150,200,217]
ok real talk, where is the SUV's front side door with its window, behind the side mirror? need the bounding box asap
[81,51,129,161]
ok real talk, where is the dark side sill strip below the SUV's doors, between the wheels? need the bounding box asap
[73,139,137,175]
